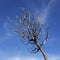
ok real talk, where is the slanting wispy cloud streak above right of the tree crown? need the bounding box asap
[38,0,55,24]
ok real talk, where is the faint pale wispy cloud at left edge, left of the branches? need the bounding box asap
[0,22,12,43]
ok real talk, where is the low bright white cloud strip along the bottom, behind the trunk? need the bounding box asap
[6,55,60,60]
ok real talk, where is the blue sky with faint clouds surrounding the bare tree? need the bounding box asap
[0,0,60,60]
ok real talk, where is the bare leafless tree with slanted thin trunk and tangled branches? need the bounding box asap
[15,9,48,60]
